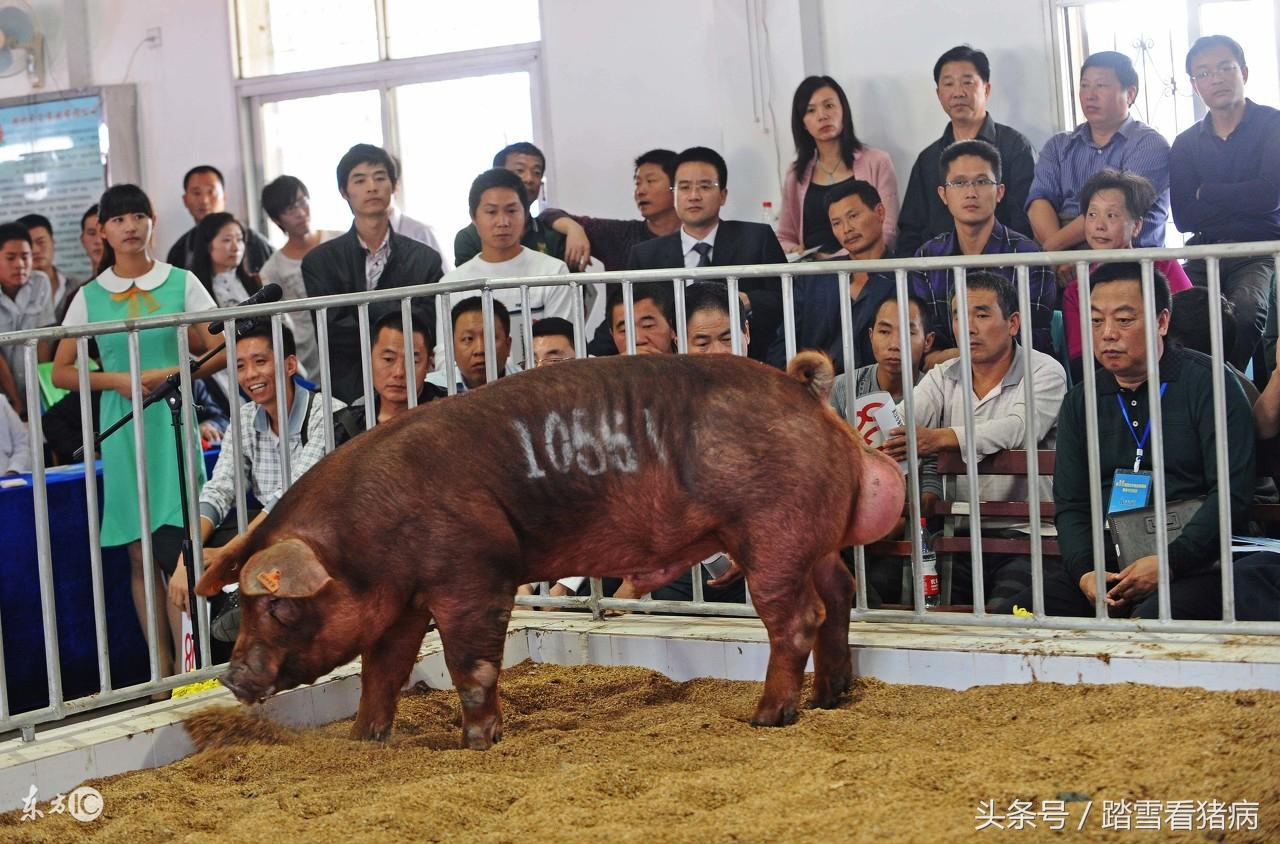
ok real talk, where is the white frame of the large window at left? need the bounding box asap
[232,0,556,239]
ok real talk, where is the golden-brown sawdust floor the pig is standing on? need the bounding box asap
[0,663,1280,844]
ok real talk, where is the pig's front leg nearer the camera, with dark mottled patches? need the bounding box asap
[436,596,515,751]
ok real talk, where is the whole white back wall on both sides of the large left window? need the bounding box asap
[0,0,1055,242]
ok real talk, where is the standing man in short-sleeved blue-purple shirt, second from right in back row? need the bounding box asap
[1027,50,1169,252]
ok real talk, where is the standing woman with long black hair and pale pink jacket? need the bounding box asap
[778,76,899,257]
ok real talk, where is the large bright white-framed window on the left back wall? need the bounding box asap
[236,0,543,251]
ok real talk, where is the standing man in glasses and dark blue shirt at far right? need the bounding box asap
[1169,35,1280,369]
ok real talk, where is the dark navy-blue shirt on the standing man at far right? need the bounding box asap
[1169,100,1280,243]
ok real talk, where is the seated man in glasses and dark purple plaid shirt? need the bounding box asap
[911,140,1057,369]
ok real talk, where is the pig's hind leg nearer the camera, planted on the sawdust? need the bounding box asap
[748,565,823,726]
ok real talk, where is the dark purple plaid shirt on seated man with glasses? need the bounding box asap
[911,220,1057,355]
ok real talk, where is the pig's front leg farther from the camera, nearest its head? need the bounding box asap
[351,610,431,742]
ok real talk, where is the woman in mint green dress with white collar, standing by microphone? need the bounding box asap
[52,184,227,675]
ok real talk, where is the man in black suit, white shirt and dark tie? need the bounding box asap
[628,146,787,360]
